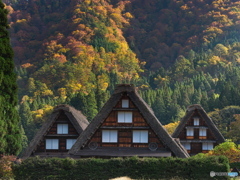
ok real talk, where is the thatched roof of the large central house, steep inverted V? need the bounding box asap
[69,84,189,158]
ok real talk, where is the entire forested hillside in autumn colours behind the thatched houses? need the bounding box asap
[1,0,240,148]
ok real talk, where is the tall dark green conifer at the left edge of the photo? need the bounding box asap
[0,0,21,154]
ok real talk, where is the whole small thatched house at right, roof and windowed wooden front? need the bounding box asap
[172,104,224,155]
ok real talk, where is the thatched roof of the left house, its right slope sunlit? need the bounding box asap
[22,104,89,158]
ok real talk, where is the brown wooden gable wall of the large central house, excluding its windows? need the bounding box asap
[83,95,164,148]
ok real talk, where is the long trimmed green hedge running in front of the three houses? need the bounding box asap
[12,156,230,180]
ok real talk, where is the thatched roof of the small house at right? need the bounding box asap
[172,104,225,143]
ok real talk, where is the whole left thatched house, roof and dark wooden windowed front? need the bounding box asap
[22,104,89,159]
